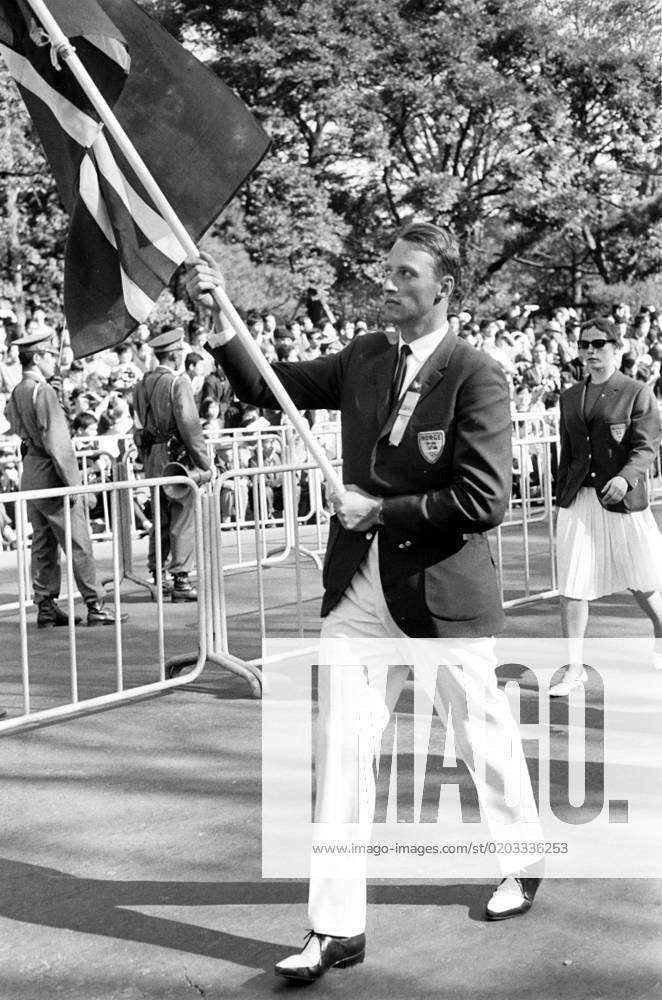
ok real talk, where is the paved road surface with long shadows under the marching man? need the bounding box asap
[0,528,662,1000]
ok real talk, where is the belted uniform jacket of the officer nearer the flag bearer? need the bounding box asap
[133,365,211,479]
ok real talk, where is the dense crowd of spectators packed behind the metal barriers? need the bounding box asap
[0,292,662,543]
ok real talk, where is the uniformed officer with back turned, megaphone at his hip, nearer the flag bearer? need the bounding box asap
[133,328,212,602]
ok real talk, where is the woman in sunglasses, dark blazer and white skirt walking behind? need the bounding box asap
[550,317,662,697]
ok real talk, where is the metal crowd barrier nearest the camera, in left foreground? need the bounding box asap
[0,468,218,734]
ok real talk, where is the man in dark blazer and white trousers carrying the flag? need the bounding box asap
[188,223,543,983]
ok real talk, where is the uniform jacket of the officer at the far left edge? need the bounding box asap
[6,371,81,490]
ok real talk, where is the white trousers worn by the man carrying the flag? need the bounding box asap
[308,539,542,937]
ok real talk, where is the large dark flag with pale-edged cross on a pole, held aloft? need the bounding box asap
[0,0,269,358]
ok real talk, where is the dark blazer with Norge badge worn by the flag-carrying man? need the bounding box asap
[213,332,511,637]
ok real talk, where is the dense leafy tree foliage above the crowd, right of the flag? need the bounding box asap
[0,0,662,322]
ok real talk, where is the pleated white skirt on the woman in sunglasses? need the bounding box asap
[556,486,662,601]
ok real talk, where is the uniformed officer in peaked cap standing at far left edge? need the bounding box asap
[7,331,126,628]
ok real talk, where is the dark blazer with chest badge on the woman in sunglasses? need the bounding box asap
[556,372,660,513]
